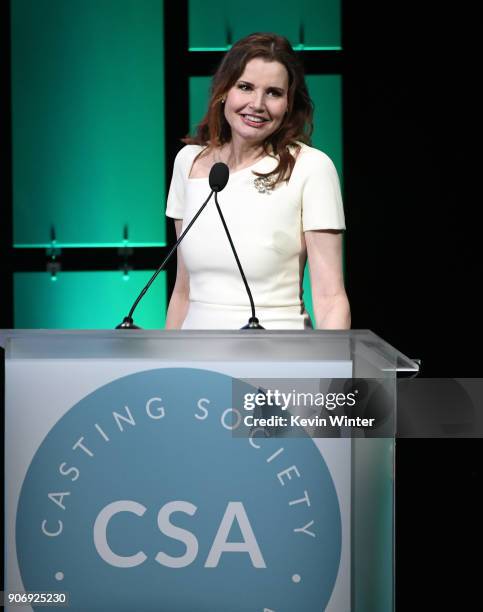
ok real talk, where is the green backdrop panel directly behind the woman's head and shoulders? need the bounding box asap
[189,75,343,324]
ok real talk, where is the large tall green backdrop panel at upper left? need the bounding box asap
[11,0,165,247]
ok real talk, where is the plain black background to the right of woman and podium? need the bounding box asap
[344,1,483,612]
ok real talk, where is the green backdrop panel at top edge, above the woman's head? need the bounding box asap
[189,0,341,51]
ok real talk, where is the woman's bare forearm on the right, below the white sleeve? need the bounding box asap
[305,230,351,329]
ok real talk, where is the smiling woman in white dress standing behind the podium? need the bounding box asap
[166,33,350,329]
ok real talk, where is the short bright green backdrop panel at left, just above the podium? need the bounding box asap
[14,270,167,329]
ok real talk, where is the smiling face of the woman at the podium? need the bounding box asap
[224,58,288,143]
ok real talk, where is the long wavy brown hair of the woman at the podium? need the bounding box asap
[182,32,314,184]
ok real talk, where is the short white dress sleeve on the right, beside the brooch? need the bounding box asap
[300,148,345,232]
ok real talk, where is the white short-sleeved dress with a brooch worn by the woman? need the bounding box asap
[166,143,345,329]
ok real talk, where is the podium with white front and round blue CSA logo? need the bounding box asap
[0,330,418,612]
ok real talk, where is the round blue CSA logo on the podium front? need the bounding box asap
[16,368,341,612]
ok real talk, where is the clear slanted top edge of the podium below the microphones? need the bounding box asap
[0,329,419,372]
